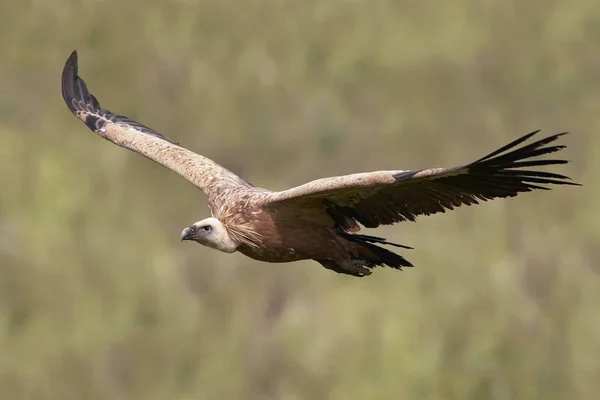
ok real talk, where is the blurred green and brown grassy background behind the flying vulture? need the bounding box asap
[0,0,600,400]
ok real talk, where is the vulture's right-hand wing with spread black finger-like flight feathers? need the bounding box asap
[269,131,577,229]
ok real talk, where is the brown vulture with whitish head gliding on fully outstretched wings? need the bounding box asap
[62,51,578,277]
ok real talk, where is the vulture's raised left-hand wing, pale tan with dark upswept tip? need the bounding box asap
[62,51,252,207]
